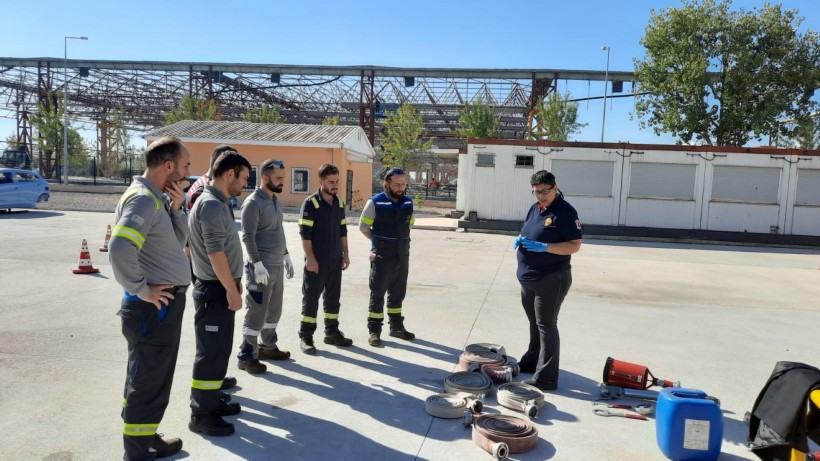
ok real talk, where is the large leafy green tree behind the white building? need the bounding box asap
[634,0,820,146]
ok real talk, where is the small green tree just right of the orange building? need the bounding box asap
[379,104,433,170]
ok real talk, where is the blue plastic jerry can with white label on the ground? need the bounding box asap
[655,387,723,461]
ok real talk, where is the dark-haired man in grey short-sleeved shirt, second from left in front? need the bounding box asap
[188,151,251,436]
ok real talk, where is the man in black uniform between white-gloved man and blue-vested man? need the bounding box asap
[299,164,353,355]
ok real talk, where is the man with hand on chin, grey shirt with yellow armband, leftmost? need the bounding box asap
[108,137,191,460]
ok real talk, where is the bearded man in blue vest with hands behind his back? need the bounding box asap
[359,168,416,347]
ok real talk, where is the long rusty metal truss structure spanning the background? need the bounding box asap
[0,58,633,174]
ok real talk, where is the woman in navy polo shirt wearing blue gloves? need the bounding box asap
[513,170,581,390]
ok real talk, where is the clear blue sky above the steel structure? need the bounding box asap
[0,0,820,146]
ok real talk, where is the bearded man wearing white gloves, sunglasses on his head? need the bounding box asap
[237,160,293,374]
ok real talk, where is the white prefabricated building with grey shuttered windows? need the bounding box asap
[457,141,820,235]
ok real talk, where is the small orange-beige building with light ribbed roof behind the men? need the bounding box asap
[145,120,375,210]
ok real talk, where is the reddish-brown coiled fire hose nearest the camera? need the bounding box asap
[472,414,538,459]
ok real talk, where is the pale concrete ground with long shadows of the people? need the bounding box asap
[0,210,820,461]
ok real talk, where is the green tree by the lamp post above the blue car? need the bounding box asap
[29,93,87,178]
